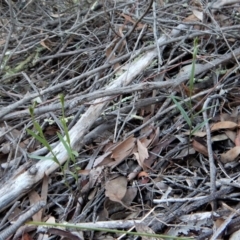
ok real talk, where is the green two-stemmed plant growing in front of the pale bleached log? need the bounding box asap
[27,94,78,187]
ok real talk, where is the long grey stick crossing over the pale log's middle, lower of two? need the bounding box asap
[0,45,240,121]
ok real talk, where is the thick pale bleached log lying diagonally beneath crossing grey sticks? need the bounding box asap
[0,30,172,211]
